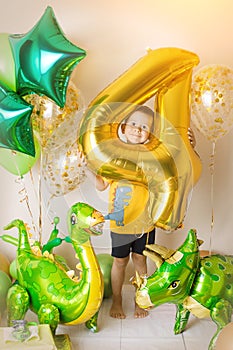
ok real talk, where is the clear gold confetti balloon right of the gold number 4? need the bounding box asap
[191,64,233,143]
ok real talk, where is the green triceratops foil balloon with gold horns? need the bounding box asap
[134,230,233,350]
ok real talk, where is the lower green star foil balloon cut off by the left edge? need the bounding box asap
[0,84,35,157]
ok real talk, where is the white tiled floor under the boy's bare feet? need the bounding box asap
[57,285,218,350]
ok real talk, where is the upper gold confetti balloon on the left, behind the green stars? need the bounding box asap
[24,82,84,151]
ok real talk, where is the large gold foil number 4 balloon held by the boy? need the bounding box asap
[79,48,201,233]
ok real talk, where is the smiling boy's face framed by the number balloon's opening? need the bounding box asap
[124,111,153,144]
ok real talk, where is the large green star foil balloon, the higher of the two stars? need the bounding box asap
[9,7,86,107]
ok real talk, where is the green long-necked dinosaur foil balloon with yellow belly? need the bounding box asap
[5,203,104,332]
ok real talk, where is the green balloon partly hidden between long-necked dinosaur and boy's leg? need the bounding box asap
[97,253,113,298]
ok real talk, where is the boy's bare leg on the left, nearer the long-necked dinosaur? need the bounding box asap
[110,256,129,319]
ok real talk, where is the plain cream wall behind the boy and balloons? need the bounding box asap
[0,0,233,278]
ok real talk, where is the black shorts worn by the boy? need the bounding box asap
[111,229,155,258]
